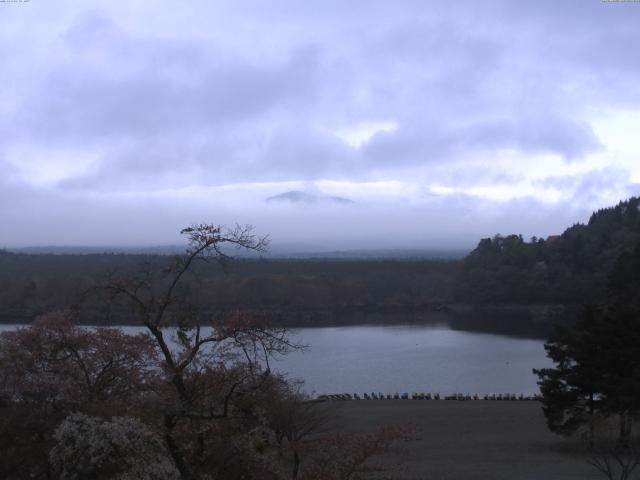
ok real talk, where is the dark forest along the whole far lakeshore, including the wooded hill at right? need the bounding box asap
[0,197,640,334]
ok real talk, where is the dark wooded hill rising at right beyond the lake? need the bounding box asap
[454,198,640,305]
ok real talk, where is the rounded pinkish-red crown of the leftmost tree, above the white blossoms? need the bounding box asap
[0,313,155,412]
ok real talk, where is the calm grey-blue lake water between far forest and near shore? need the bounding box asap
[0,325,551,395]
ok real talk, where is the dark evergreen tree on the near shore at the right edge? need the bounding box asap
[534,307,640,444]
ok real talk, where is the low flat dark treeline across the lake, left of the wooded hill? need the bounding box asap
[0,252,457,324]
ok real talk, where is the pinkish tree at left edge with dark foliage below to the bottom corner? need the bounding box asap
[0,313,157,478]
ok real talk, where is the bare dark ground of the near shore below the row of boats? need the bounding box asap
[336,400,602,480]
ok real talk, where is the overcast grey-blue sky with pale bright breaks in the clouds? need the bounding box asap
[0,0,640,250]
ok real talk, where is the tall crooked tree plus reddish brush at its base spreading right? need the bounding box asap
[100,224,416,480]
